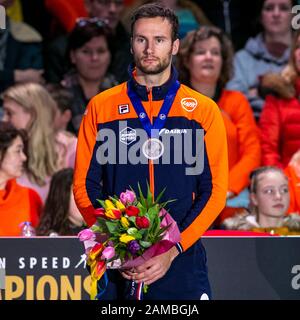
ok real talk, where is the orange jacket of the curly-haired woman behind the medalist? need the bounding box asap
[217,90,261,194]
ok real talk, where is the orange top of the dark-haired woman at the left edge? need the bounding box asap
[0,179,42,236]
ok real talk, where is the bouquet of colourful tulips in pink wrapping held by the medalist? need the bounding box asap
[78,185,180,300]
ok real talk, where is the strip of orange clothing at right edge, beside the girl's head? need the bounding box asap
[284,166,300,214]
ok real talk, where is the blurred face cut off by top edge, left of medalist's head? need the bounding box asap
[85,0,124,30]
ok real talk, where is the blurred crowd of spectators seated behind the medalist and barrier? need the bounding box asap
[0,0,300,236]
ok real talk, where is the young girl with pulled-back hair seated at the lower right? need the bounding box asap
[223,166,300,235]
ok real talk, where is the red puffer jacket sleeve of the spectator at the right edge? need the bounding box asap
[259,96,282,168]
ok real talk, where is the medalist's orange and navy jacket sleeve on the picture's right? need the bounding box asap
[180,101,228,251]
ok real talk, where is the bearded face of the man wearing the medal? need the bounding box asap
[131,17,179,74]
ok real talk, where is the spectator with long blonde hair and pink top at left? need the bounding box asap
[3,83,75,202]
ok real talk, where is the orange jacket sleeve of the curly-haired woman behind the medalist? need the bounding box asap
[228,95,261,194]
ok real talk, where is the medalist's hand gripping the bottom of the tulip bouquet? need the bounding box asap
[121,247,178,285]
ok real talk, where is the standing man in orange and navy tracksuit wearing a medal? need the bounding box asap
[74,4,228,300]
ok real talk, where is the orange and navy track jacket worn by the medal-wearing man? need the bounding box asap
[74,68,228,251]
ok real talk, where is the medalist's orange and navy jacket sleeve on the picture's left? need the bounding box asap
[73,99,102,226]
